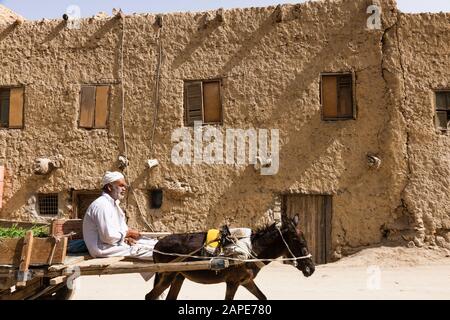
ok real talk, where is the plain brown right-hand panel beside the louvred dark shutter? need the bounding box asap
[203,81,222,123]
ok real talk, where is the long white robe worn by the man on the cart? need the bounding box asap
[83,192,158,278]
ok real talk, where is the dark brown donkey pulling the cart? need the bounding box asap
[145,216,315,300]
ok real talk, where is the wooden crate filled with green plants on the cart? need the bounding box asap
[0,223,67,266]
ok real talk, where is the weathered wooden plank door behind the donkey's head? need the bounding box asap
[283,195,332,264]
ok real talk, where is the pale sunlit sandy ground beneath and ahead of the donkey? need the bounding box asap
[73,247,450,300]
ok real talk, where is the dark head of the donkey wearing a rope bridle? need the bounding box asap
[281,216,316,277]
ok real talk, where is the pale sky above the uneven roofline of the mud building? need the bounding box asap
[0,0,450,20]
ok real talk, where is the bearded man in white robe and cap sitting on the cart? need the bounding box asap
[83,171,157,260]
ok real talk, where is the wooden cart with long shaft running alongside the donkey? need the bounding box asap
[0,220,234,300]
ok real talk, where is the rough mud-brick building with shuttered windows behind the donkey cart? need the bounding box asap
[0,0,450,263]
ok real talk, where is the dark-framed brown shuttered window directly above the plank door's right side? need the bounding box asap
[321,74,355,120]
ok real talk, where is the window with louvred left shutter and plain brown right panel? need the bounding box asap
[184,80,222,126]
